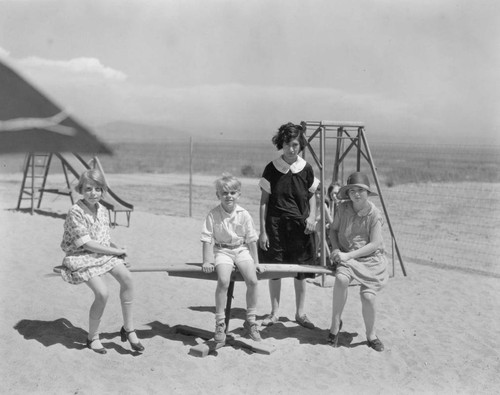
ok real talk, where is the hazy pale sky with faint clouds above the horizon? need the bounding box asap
[0,0,500,145]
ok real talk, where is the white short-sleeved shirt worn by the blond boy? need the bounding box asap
[201,204,258,245]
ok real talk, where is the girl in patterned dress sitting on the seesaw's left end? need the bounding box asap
[61,169,144,354]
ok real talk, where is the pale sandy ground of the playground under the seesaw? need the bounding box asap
[0,176,500,394]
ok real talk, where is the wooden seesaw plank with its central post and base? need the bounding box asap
[54,263,333,357]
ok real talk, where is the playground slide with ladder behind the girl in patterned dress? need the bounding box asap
[16,152,134,226]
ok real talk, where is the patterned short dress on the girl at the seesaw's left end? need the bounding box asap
[61,200,123,284]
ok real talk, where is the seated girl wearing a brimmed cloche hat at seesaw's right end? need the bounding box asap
[328,172,388,351]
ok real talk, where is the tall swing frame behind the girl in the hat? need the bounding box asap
[301,121,406,280]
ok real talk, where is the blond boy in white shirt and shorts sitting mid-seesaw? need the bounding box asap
[201,173,262,343]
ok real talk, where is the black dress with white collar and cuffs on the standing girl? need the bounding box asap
[259,157,318,279]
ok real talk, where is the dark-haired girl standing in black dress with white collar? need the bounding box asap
[259,123,319,329]
